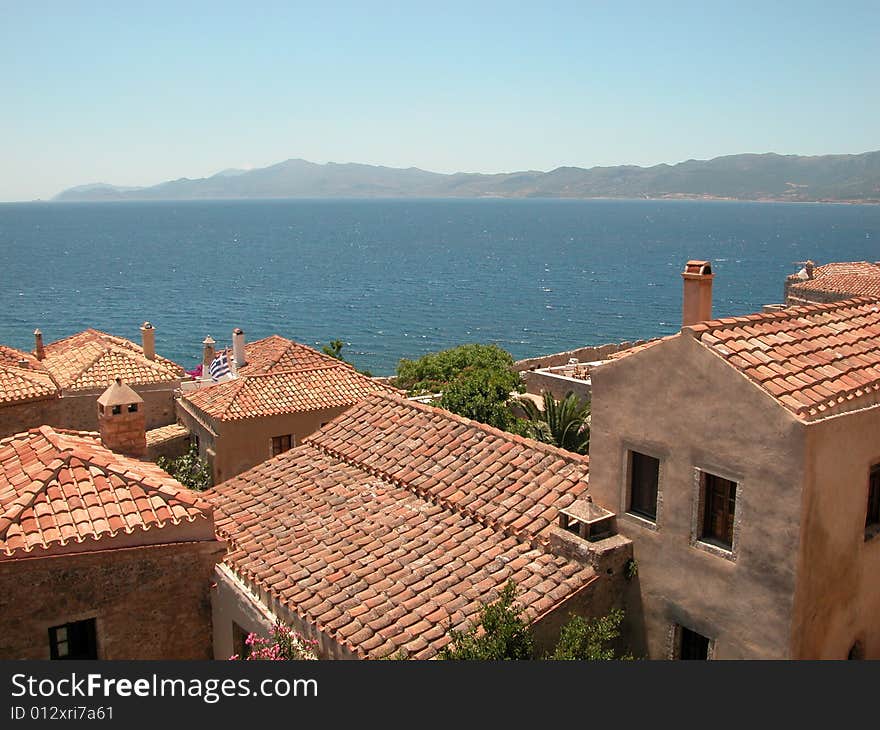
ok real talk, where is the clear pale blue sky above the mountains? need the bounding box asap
[0,0,880,200]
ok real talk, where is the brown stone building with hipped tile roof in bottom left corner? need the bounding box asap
[0,406,225,659]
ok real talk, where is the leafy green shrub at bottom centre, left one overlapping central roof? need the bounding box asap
[440,581,534,660]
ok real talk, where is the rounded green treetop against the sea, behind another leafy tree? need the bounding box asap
[395,344,522,395]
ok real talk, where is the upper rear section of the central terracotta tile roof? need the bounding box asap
[306,393,589,545]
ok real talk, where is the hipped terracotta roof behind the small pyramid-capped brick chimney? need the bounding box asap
[43,329,185,391]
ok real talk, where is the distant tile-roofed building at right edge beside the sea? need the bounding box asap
[785,261,880,307]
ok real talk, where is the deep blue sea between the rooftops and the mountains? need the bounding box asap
[0,200,880,374]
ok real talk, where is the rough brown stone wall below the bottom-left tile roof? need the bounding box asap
[0,540,225,659]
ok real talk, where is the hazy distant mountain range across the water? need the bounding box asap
[54,151,880,203]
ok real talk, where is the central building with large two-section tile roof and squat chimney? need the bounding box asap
[205,392,632,659]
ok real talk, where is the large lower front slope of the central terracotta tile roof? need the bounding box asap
[206,438,596,659]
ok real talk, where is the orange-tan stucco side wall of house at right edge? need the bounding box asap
[793,406,880,659]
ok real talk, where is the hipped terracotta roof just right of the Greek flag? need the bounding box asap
[183,335,400,421]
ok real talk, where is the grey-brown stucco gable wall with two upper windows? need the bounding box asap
[590,336,805,658]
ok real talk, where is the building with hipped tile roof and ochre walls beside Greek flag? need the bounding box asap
[177,330,398,484]
